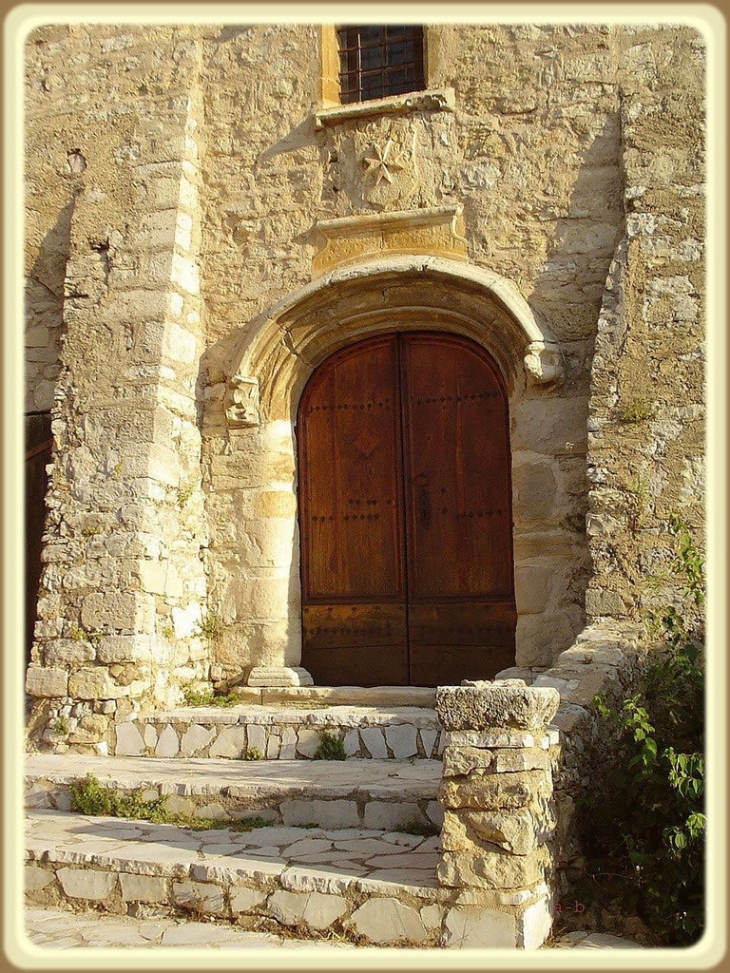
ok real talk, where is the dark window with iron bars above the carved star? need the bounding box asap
[337,24,425,105]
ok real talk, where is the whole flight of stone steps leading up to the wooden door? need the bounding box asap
[25,687,548,948]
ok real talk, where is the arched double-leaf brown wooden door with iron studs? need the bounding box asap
[297,332,516,686]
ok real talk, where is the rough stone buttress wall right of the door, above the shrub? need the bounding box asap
[586,27,705,618]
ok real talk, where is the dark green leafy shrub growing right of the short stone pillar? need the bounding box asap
[580,516,705,946]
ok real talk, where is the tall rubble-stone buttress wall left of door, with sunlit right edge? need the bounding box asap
[27,27,208,752]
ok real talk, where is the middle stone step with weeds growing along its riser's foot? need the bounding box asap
[25,753,443,829]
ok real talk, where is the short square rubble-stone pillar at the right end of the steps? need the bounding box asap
[436,679,560,949]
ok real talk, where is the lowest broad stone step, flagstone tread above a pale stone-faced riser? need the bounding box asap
[25,810,544,948]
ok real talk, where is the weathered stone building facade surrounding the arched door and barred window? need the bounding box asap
[25,24,705,752]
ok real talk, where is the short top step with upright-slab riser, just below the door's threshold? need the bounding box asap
[114,708,444,760]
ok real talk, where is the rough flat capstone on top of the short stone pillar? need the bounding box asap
[436,682,560,730]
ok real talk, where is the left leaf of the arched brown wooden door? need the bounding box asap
[298,335,408,685]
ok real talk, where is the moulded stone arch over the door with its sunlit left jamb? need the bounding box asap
[211,256,561,684]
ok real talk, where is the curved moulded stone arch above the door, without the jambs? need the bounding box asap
[230,255,562,420]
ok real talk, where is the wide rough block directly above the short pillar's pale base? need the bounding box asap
[436,848,547,889]
